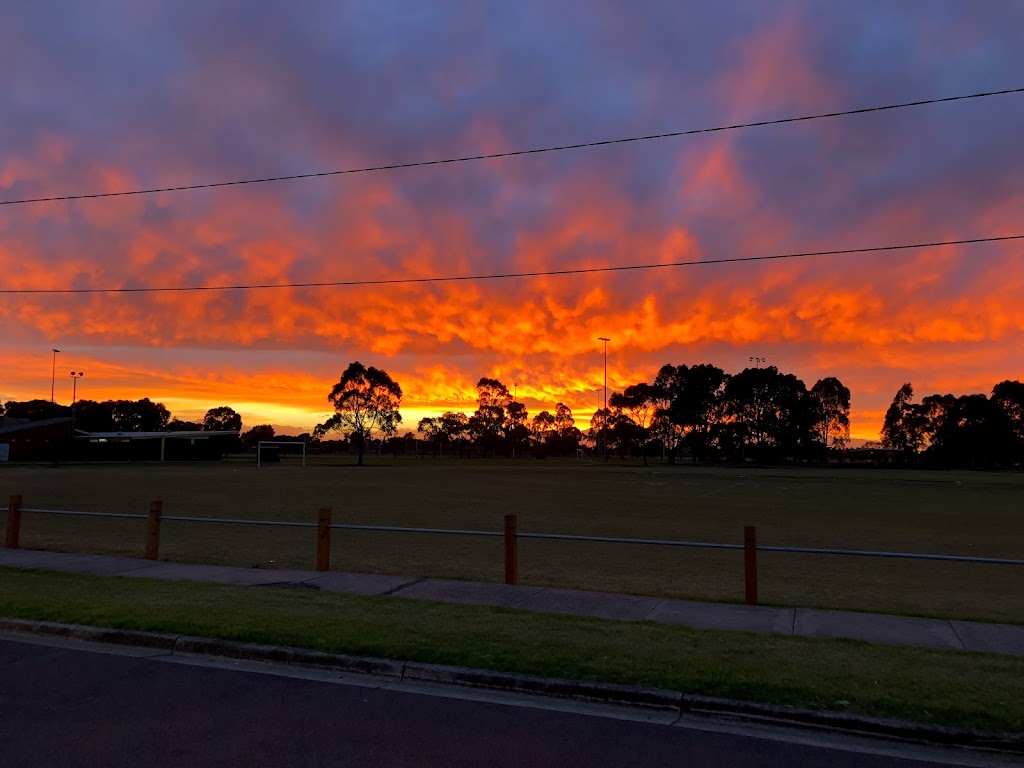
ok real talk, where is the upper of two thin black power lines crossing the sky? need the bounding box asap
[0,87,1024,206]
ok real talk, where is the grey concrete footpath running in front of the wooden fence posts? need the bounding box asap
[0,549,1024,655]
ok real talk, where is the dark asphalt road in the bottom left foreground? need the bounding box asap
[0,639,1007,768]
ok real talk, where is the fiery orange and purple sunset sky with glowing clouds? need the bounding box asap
[0,0,1024,439]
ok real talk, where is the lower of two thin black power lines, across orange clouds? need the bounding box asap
[0,234,1024,294]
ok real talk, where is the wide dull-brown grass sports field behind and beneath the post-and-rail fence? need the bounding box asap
[0,457,1024,623]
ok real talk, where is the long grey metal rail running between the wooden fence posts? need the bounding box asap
[9,507,1024,565]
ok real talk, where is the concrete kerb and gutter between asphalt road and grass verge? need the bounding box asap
[0,617,1024,755]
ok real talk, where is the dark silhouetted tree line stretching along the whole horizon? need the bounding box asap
[9,361,1024,468]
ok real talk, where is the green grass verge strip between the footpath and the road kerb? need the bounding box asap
[0,568,1024,732]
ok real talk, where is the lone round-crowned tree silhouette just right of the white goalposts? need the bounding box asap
[315,360,401,466]
